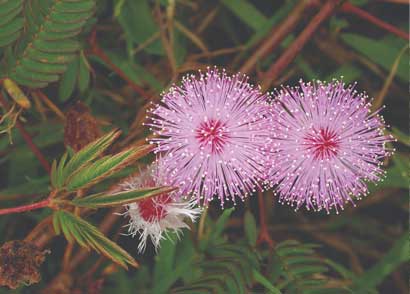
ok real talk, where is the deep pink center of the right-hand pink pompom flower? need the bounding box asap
[303,128,340,159]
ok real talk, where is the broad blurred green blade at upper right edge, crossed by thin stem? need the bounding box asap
[341,33,409,82]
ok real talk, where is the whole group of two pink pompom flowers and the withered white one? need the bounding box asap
[118,68,393,251]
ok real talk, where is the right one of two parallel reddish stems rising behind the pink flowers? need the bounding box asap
[262,0,340,90]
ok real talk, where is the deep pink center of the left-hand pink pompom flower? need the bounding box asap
[195,119,229,154]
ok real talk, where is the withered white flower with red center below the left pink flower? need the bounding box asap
[119,164,201,252]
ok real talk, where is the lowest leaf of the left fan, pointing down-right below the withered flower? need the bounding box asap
[53,210,138,268]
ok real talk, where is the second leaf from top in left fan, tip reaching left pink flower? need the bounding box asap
[67,145,152,191]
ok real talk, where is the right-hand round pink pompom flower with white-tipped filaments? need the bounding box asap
[269,81,392,212]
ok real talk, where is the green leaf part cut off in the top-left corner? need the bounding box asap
[0,0,24,47]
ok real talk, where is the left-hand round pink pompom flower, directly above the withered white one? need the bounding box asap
[147,69,270,206]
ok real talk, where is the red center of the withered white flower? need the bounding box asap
[137,194,171,222]
